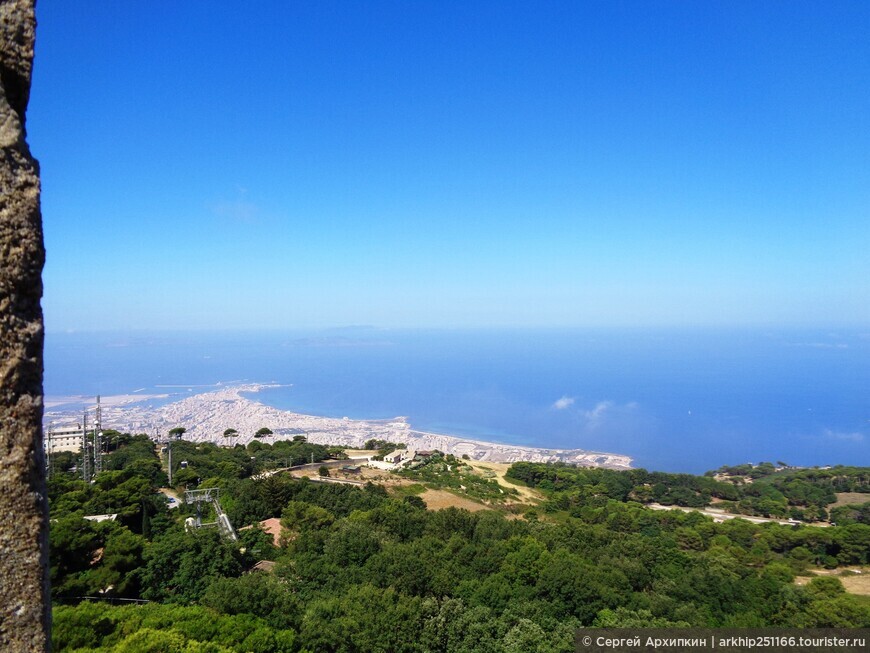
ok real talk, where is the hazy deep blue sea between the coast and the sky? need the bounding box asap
[45,328,870,473]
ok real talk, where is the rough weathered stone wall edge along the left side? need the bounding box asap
[0,0,50,652]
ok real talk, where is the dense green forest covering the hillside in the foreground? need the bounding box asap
[49,434,870,653]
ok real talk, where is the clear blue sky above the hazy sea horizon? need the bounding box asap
[28,0,870,331]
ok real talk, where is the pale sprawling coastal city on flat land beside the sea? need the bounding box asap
[43,383,632,469]
